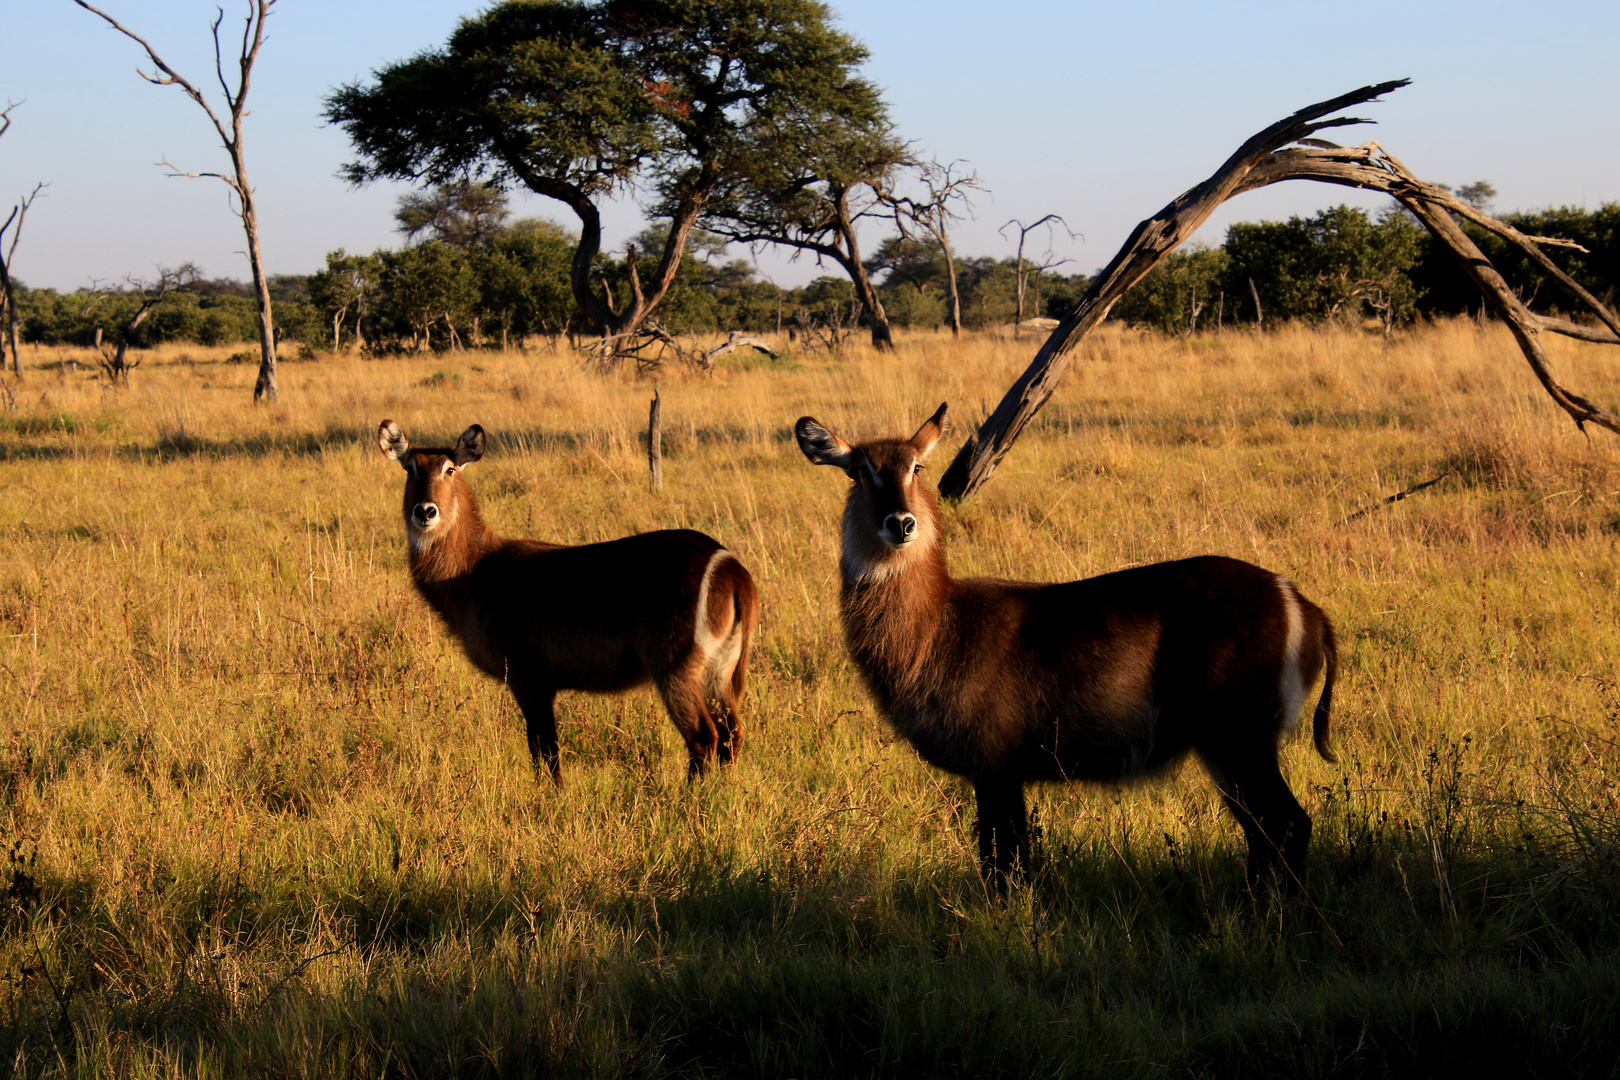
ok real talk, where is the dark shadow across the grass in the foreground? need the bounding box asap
[9,823,1620,1077]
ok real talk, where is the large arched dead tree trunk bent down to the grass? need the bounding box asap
[940,79,1620,499]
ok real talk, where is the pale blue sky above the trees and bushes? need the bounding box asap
[0,0,1620,290]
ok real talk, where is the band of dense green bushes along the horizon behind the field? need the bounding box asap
[18,202,1620,350]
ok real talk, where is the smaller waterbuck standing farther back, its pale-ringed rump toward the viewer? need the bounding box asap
[377,419,760,784]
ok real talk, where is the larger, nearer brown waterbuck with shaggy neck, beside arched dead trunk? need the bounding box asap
[795,405,1337,889]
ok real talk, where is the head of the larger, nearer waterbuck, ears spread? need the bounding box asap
[794,405,948,578]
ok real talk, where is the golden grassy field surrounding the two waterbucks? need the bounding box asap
[0,322,1620,1077]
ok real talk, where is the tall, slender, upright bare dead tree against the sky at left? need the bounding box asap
[73,0,277,402]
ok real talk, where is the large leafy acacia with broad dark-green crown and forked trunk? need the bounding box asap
[326,0,875,348]
